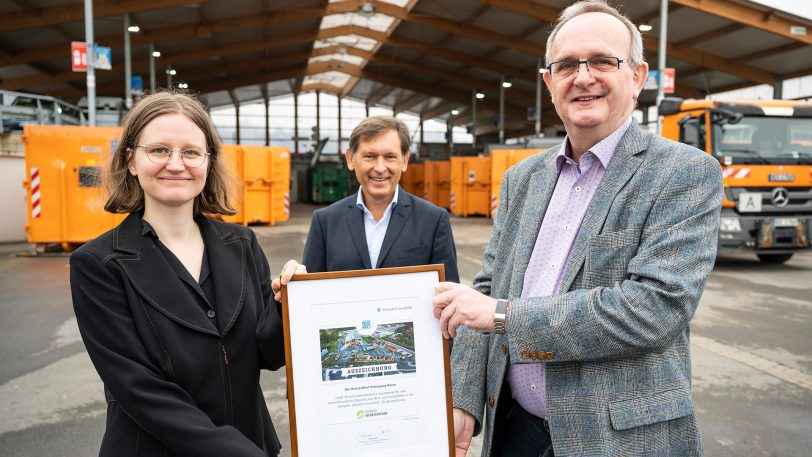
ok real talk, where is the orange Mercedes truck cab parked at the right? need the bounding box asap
[659,98,812,264]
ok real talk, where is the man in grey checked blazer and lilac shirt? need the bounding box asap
[434,0,722,457]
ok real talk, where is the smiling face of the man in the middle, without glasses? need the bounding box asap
[344,130,409,207]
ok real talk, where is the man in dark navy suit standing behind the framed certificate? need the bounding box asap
[302,116,459,282]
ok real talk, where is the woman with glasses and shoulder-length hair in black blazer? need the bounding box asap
[70,92,296,457]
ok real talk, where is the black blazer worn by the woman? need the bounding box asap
[70,214,285,457]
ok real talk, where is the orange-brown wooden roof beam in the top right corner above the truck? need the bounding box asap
[671,0,812,44]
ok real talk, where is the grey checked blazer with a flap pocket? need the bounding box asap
[451,122,722,457]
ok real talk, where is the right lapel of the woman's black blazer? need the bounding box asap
[198,216,246,336]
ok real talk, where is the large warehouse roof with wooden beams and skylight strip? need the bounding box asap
[0,0,812,134]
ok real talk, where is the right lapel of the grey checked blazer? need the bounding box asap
[558,121,649,292]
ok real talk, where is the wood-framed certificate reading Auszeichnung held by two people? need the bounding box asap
[282,265,454,457]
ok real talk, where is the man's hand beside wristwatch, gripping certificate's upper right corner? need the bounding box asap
[434,282,496,338]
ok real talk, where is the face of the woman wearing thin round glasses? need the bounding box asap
[127,113,209,213]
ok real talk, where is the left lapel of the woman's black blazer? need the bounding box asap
[114,213,219,335]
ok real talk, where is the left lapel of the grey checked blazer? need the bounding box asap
[507,150,560,297]
